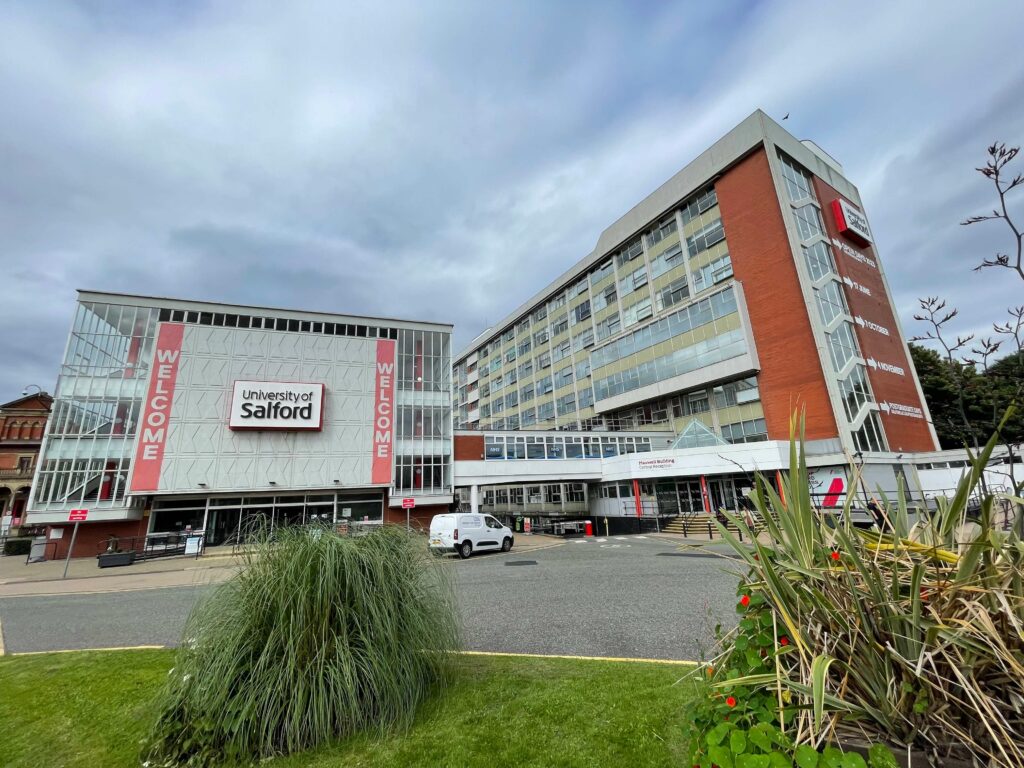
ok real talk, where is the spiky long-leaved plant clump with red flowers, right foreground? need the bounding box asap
[691,411,1024,768]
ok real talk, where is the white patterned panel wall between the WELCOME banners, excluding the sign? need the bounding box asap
[160,326,377,493]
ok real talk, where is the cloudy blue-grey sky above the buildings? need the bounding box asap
[0,0,1024,401]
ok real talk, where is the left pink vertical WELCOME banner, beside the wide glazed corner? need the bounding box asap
[131,323,185,492]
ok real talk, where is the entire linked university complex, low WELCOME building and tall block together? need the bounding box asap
[29,111,938,556]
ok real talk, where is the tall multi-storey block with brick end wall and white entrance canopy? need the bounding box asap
[453,111,938,528]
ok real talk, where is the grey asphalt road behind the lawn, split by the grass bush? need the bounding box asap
[0,537,736,659]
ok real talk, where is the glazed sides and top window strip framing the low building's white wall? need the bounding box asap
[31,301,452,512]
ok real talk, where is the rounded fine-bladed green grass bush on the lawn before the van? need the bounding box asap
[143,526,459,766]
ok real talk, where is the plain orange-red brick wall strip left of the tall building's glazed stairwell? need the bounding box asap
[715,147,839,440]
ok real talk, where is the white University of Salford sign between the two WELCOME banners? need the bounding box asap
[227,381,324,431]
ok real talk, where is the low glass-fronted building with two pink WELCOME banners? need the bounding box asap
[29,291,453,557]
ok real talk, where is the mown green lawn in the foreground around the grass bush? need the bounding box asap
[0,650,691,768]
